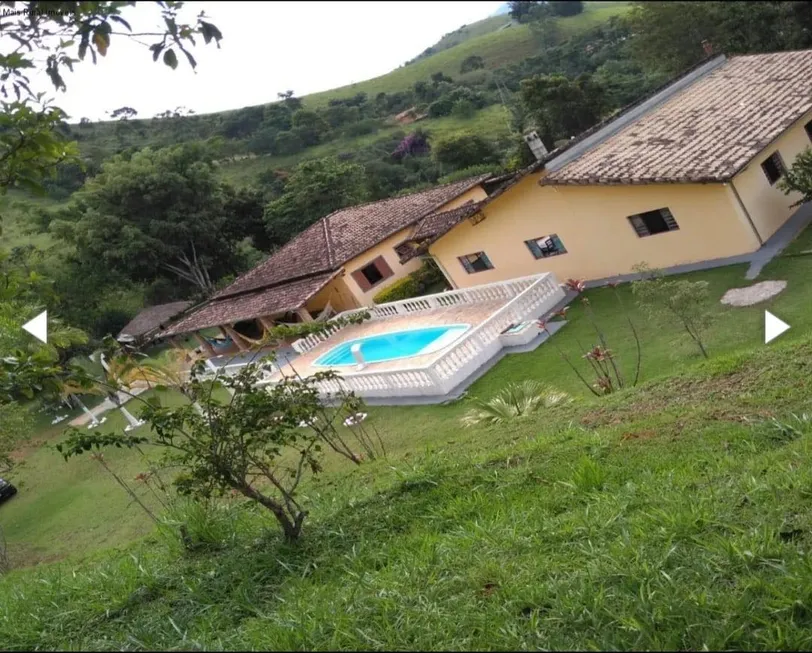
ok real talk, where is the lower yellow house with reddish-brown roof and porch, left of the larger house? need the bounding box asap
[158,174,492,348]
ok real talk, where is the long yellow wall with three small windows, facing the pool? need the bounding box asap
[429,174,759,288]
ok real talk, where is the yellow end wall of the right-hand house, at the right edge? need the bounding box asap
[733,111,812,240]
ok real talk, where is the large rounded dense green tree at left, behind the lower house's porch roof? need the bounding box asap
[50,144,261,293]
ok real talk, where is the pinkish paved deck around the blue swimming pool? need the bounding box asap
[272,300,507,379]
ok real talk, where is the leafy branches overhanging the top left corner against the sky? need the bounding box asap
[0,1,222,192]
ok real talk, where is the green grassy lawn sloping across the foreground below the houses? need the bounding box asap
[0,224,812,650]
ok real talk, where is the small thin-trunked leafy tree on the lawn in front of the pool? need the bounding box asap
[57,332,386,541]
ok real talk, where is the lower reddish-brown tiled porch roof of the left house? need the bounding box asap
[160,272,335,336]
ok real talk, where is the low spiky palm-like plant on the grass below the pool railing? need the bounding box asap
[462,379,572,426]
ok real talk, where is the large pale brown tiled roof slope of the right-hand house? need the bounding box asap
[541,50,812,185]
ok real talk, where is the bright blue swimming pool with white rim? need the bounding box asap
[313,324,471,367]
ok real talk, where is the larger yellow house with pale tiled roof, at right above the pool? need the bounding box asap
[402,50,812,288]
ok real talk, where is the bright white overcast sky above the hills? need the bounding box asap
[37,1,502,122]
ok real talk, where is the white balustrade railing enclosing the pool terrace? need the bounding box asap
[294,273,565,397]
